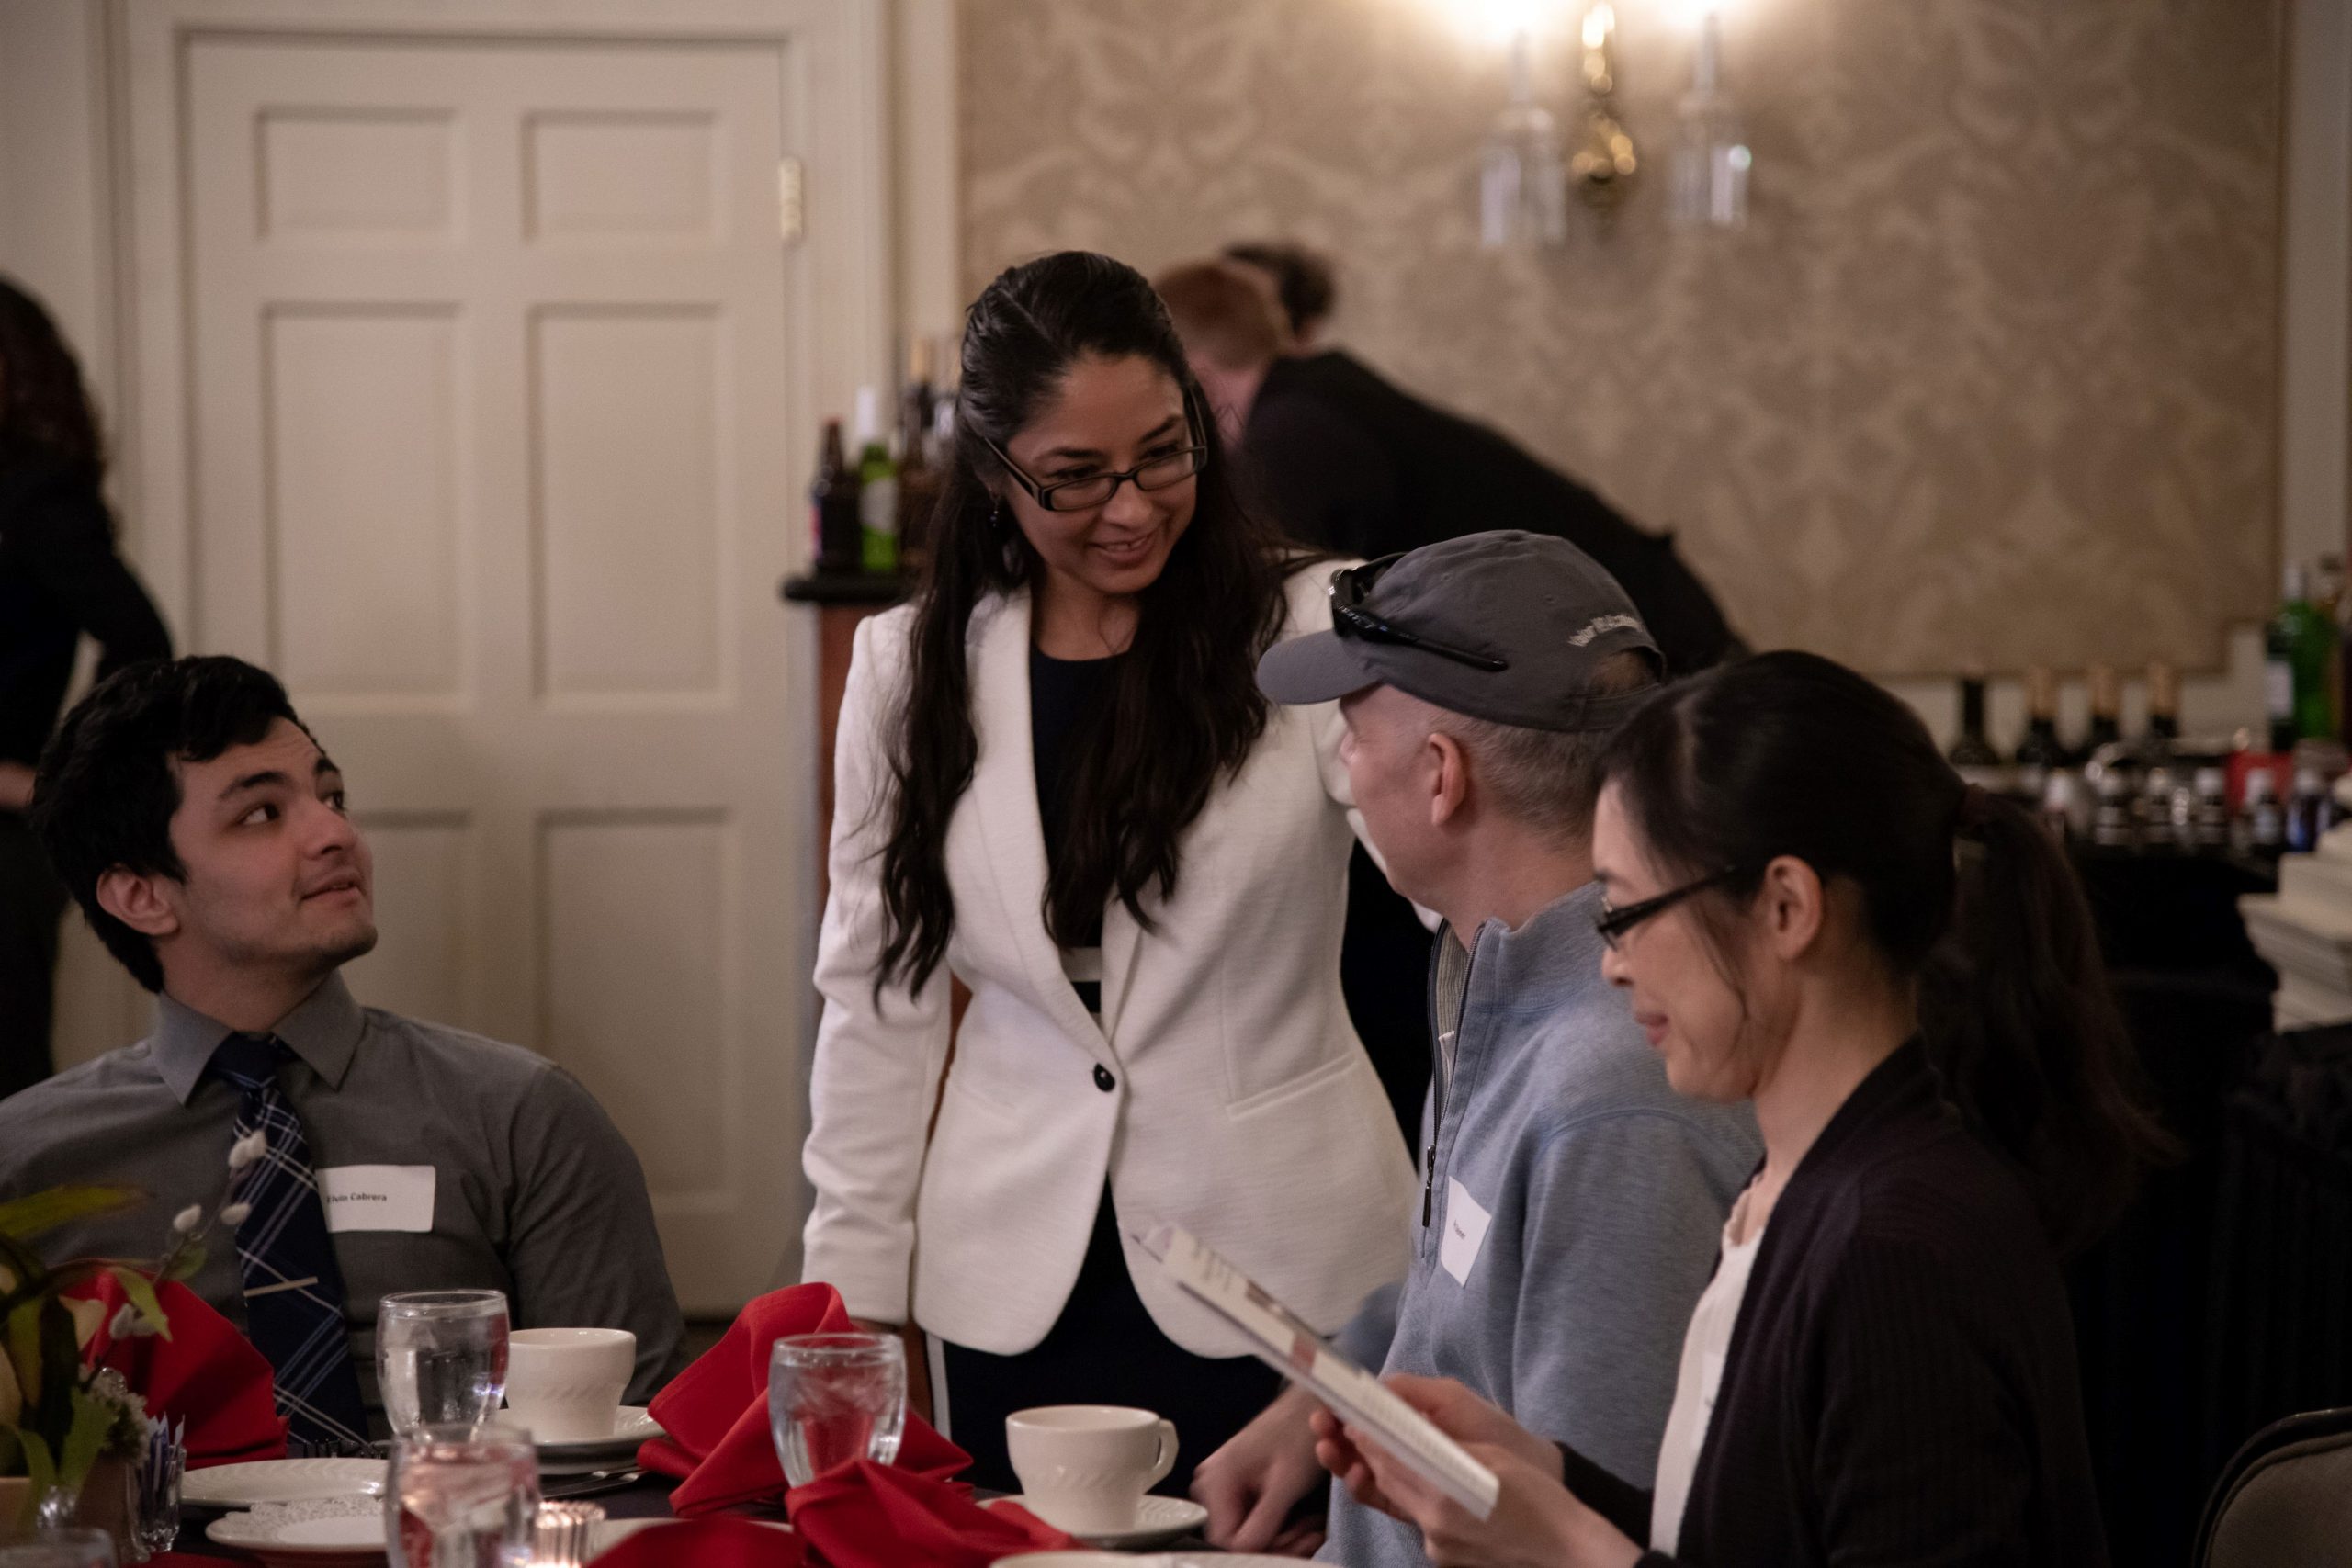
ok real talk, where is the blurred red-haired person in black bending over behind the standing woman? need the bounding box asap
[1158,261,1740,674]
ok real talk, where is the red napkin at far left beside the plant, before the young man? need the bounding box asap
[68,1274,287,1470]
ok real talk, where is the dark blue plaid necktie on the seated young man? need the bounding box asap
[211,1034,367,1446]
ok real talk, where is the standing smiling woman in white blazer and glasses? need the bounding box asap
[805,252,1414,1493]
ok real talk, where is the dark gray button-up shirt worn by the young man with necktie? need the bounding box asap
[0,976,684,1404]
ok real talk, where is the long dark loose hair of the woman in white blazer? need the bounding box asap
[877,252,1284,989]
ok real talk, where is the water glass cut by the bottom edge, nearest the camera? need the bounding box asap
[383,1422,538,1568]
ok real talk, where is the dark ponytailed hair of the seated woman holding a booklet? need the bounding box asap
[1604,653,2166,1248]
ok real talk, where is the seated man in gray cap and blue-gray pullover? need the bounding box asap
[1193,531,1761,1568]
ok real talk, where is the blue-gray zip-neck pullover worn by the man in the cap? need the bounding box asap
[1319,884,1764,1568]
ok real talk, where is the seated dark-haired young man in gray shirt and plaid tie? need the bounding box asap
[0,659,684,1443]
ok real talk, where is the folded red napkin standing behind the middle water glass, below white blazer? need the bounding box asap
[638,1286,971,1518]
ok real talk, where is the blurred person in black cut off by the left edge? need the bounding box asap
[0,277,172,1098]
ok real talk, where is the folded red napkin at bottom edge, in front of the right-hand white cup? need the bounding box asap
[786,1460,1077,1568]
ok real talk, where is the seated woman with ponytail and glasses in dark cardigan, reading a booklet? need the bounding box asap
[1322,653,2162,1568]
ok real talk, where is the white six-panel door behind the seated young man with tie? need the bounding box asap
[184,33,809,1309]
